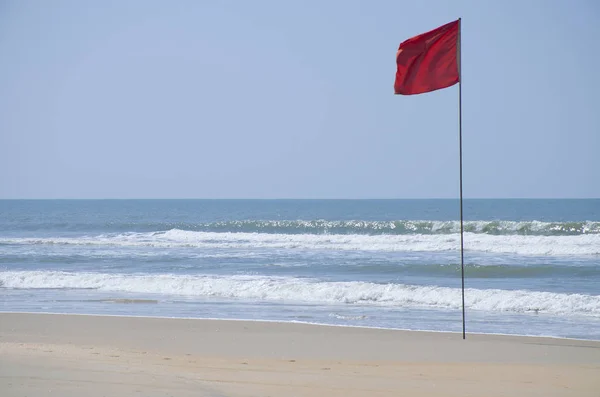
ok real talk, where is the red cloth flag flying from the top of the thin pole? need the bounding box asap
[394,20,460,95]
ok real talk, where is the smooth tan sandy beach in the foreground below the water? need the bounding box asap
[0,313,600,397]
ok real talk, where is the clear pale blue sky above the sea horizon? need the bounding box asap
[0,0,600,199]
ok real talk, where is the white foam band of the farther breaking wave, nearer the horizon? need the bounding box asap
[0,229,600,256]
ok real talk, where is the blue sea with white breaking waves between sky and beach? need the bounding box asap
[0,199,600,340]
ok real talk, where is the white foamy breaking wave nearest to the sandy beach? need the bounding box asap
[0,271,600,317]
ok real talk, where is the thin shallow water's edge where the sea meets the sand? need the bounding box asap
[0,310,600,343]
